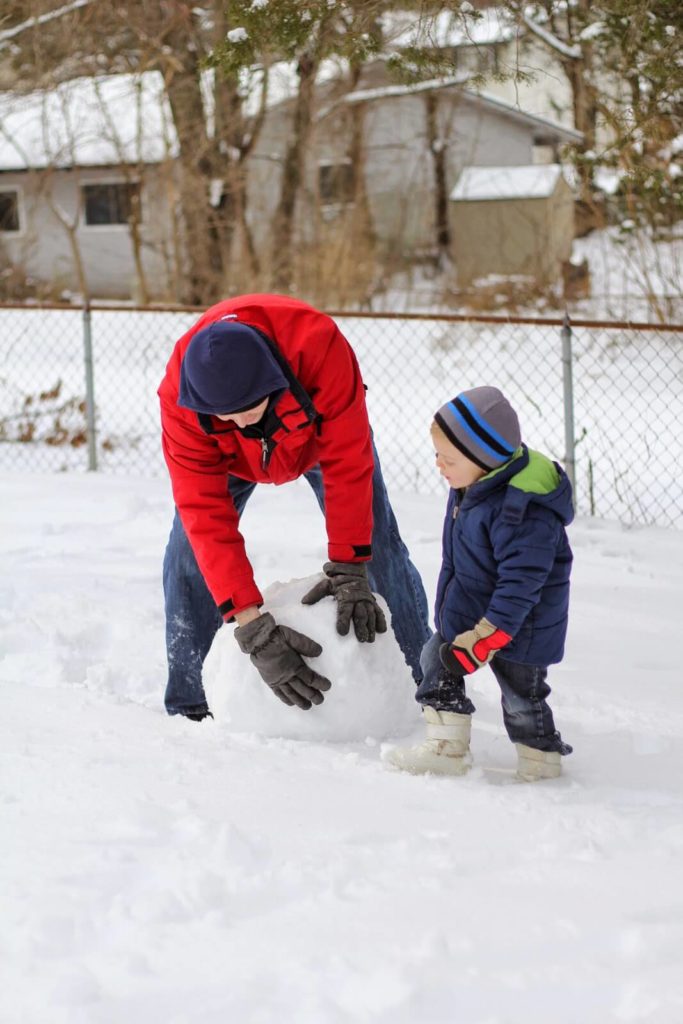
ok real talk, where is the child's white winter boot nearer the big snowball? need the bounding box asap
[385,706,472,775]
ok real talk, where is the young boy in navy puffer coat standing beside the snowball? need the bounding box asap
[387,387,573,781]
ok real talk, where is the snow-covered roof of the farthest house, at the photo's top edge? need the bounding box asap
[382,4,517,49]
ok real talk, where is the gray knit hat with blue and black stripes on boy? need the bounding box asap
[434,387,521,472]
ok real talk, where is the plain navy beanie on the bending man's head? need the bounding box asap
[178,319,288,415]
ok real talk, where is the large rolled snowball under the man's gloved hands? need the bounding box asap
[204,574,419,742]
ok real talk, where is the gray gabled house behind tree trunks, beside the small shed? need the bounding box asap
[242,61,582,257]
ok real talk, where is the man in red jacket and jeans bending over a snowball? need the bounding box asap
[159,295,430,720]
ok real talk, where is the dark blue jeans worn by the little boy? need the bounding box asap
[415,633,571,754]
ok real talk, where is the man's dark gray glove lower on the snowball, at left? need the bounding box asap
[234,612,332,711]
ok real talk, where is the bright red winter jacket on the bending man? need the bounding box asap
[159,295,373,622]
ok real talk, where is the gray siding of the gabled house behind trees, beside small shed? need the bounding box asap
[248,87,533,256]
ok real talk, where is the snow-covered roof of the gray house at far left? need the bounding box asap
[0,72,177,171]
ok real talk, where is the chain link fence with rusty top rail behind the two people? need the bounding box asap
[0,305,683,528]
